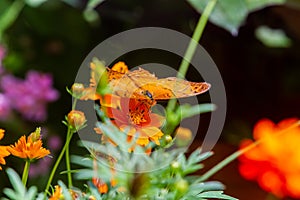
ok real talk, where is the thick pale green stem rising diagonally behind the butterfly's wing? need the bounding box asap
[166,0,217,127]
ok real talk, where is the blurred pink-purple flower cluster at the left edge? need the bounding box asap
[1,71,59,121]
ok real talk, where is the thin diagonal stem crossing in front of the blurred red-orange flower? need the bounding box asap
[198,121,300,182]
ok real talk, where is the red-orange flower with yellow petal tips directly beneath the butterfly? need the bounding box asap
[100,94,164,146]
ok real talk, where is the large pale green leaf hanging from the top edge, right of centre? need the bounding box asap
[187,0,285,35]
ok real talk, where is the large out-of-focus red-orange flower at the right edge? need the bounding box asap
[239,119,300,199]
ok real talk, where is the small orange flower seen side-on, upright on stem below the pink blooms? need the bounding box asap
[8,135,50,160]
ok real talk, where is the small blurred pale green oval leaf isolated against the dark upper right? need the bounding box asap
[255,26,292,48]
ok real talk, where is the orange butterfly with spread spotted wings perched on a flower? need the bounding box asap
[107,62,211,101]
